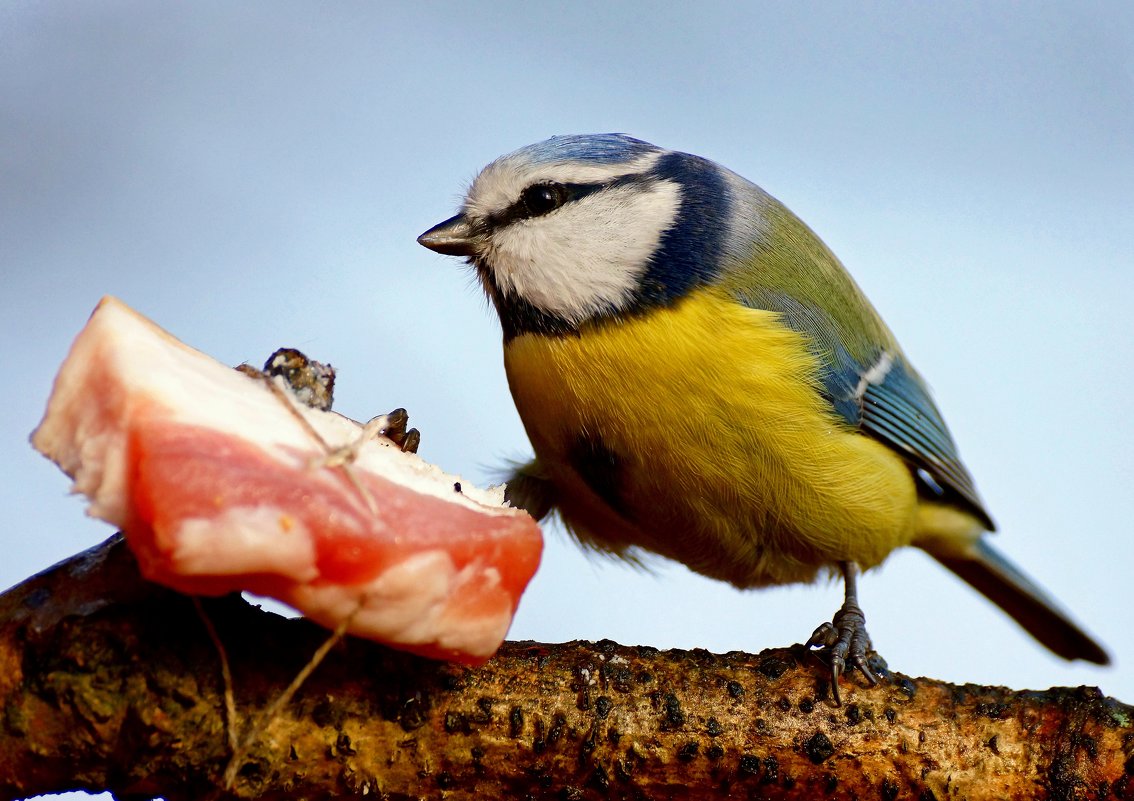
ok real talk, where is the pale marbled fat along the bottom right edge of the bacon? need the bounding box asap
[284,550,511,657]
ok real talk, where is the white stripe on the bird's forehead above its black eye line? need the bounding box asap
[464,151,663,218]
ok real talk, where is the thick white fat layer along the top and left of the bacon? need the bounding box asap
[32,297,518,526]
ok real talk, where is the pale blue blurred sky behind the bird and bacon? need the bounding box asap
[0,2,1134,789]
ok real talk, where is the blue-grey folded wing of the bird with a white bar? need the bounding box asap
[738,293,996,531]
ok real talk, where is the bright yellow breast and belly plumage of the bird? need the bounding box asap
[505,290,917,587]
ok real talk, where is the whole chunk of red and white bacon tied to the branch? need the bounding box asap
[32,297,543,664]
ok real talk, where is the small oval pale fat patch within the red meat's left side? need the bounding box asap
[169,506,319,581]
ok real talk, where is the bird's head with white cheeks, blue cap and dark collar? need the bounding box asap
[417,134,755,337]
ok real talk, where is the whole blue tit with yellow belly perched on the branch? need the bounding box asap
[418,134,1108,700]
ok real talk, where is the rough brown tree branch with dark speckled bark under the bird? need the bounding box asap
[0,538,1134,801]
